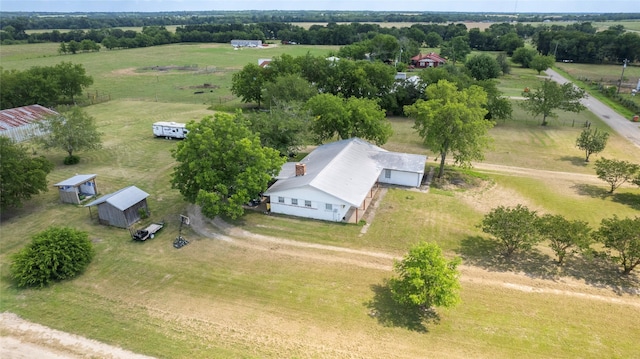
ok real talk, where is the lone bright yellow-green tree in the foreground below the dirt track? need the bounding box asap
[389,242,460,310]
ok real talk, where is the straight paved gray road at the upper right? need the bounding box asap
[546,69,640,148]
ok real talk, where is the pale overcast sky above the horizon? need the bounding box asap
[0,0,640,13]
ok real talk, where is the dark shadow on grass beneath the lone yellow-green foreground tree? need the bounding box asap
[365,281,440,333]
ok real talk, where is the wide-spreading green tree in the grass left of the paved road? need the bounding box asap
[521,79,585,126]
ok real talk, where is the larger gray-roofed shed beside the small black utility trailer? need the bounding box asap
[85,186,149,228]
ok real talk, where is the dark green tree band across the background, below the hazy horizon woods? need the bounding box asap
[0,14,640,63]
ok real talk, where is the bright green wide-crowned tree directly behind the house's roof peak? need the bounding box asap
[306,94,393,145]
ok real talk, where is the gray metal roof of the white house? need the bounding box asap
[265,138,426,206]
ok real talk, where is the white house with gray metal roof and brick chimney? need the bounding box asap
[265,138,427,222]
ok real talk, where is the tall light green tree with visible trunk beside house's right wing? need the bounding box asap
[405,80,494,178]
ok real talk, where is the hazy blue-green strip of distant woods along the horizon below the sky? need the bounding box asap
[0,10,640,32]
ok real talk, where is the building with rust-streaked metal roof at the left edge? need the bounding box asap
[0,105,60,143]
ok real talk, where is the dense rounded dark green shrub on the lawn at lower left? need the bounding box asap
[11,227,95,287]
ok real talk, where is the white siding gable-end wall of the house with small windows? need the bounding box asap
[270,188,351,222]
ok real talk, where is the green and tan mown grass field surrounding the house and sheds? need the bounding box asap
[0,41,640,358]
